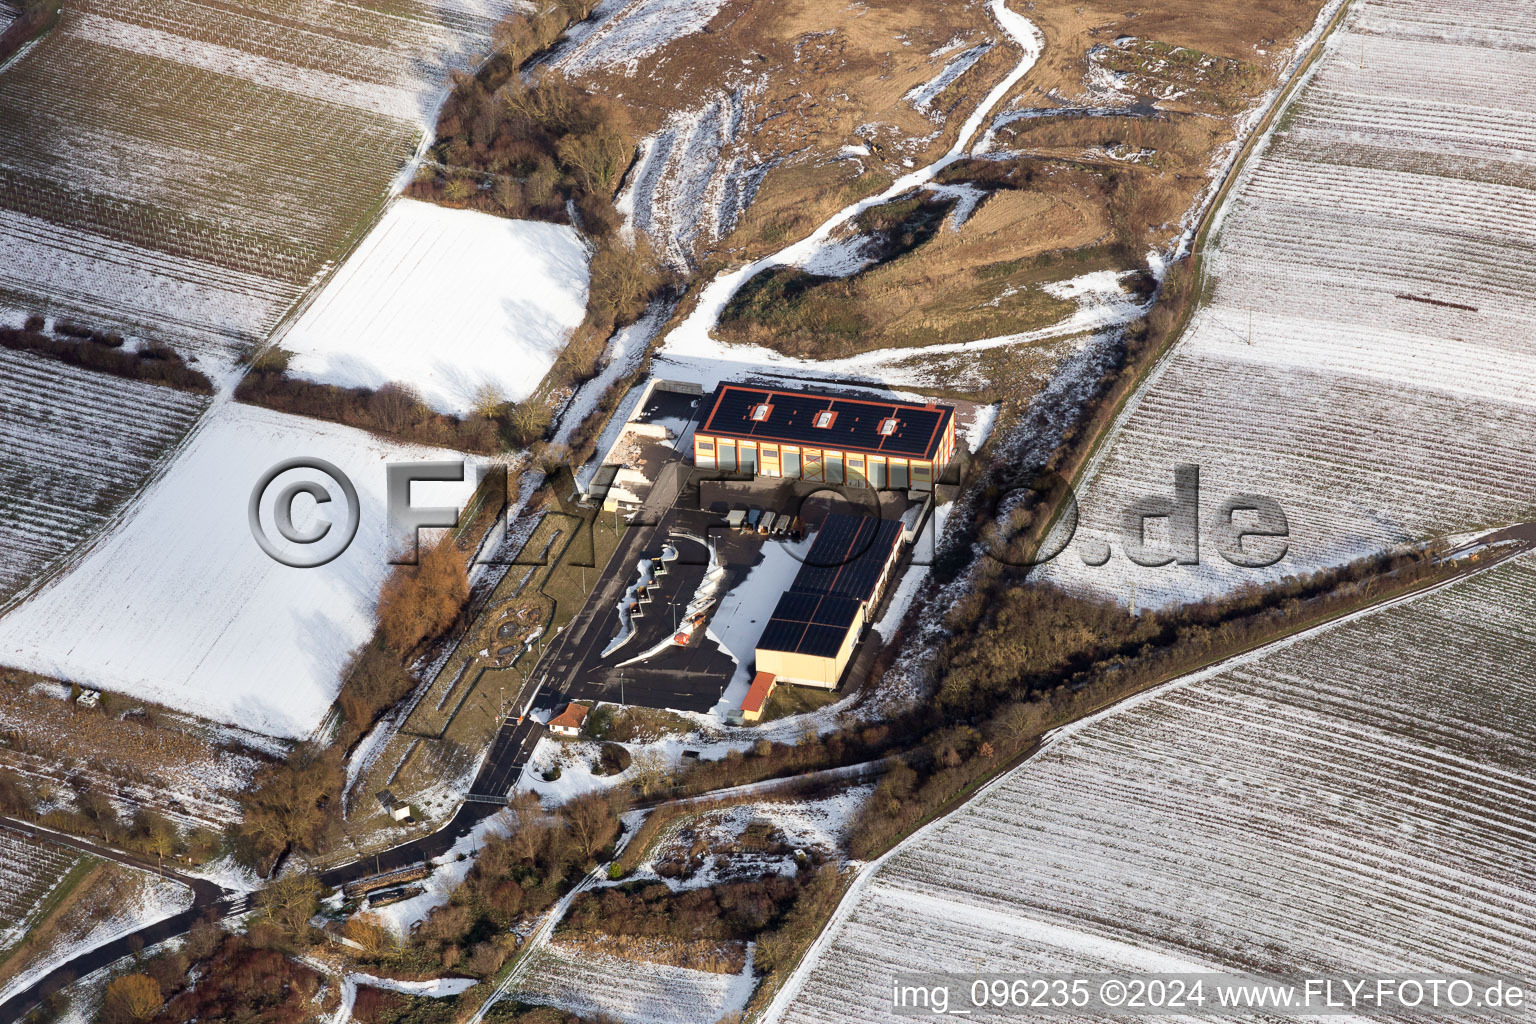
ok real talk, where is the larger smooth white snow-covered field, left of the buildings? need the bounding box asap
[0,404,475,738]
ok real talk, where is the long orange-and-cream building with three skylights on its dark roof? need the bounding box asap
[693,384,955,491]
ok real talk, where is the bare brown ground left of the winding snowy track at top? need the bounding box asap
[578,0,1018,268]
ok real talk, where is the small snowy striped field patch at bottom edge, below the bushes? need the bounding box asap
[515,943,756,1024]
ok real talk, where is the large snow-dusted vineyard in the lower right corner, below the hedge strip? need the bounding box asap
[770,556,1536,1022]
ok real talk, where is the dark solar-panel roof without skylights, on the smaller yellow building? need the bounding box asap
[757,513,902,657]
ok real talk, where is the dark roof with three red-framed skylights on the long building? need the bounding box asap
[699,384,955,459]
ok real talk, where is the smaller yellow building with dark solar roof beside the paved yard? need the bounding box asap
[757,514,909,689]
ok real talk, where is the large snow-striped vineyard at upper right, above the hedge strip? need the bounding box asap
[1048,0,1536,605]
